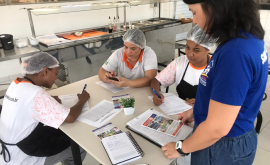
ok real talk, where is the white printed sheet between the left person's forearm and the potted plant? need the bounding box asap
[78,100,121,127]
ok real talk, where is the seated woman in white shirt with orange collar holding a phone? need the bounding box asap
[98,29,157,87]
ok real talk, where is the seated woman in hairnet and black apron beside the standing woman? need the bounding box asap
[151,26,215,109]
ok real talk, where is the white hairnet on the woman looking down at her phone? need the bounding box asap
[123,29,146,49]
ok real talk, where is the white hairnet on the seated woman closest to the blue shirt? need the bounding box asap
[187,25,217,50]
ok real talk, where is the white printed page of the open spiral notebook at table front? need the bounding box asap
[101,133,141,164]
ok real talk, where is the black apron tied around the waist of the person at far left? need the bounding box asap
[0,77,70,162]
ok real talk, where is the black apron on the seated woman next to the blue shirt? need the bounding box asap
[176,63,198,100]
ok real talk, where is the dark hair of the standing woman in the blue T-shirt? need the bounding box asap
[200,0,265,45]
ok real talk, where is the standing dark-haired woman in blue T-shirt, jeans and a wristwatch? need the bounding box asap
[162,0,268,165]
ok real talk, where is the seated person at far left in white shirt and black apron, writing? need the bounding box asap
[0,52,90,165]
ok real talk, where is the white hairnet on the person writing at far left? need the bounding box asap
[21,52,59,75]
